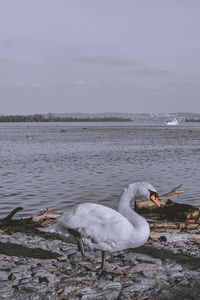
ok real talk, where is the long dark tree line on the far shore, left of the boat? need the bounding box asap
[0,114,132,122]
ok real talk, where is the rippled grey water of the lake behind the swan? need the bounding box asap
[0,123,200,216]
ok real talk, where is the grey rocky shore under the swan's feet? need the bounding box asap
[0,228,200,300]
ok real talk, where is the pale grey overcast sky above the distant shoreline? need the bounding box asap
[0,0,200,115]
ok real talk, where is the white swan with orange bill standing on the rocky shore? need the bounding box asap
[41,182,160,270]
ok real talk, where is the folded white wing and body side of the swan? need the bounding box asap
[57,203,133,251]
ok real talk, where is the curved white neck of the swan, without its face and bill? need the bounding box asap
[118,182,149,244]
